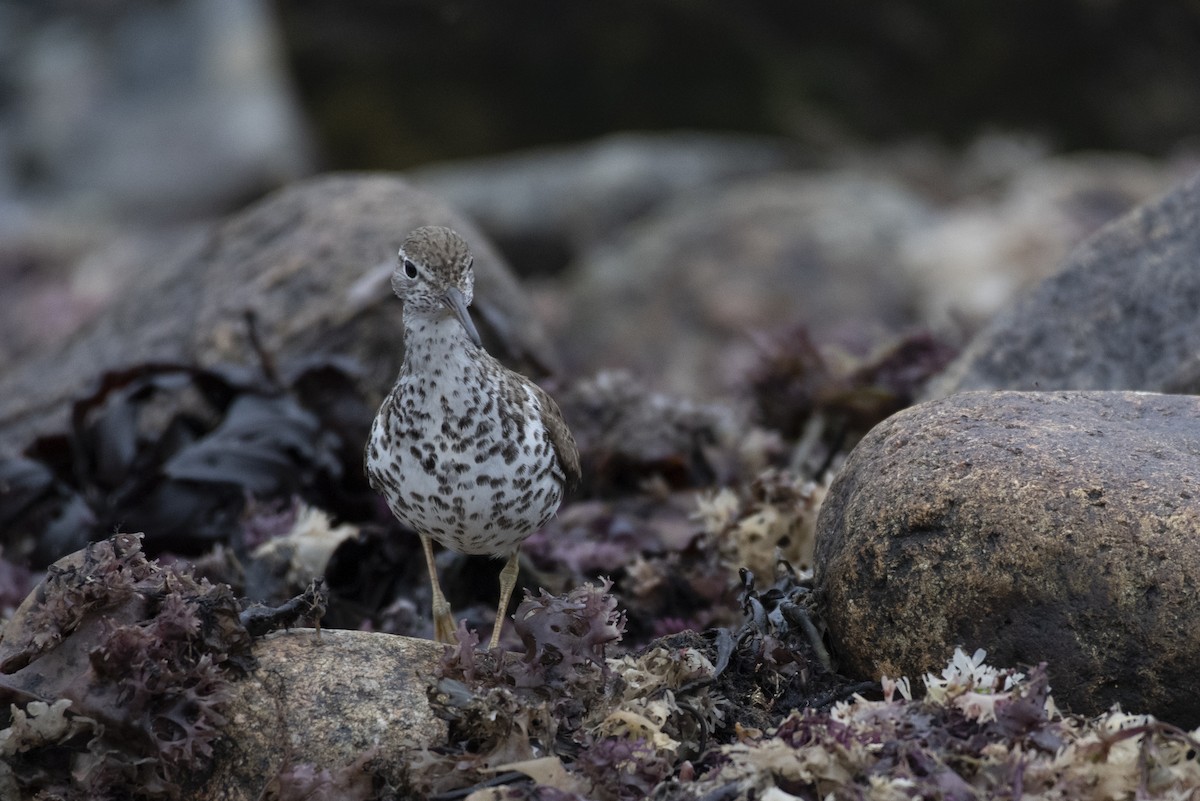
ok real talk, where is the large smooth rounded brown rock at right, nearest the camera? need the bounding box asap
[815,392,1200,728]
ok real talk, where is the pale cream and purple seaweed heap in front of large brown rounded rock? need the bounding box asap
[678,649,1200,801]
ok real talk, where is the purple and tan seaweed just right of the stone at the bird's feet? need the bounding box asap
[415,575,854,801]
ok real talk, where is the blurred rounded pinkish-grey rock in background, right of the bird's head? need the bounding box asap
[559,171,930,397]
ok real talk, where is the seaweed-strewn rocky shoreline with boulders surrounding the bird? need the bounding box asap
[0,138,1200,800]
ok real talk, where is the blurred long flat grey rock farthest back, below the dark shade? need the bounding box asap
[406,132,800,275]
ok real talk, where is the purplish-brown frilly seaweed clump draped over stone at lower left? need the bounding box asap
[0,534,253,799]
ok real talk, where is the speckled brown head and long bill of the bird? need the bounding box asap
[391,225,480,345]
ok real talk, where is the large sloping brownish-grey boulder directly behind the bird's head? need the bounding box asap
[0,175,554,452]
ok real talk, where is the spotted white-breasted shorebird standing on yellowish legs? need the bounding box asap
[365,225,581,650]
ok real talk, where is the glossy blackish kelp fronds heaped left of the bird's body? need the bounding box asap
[0,362,370,567]
